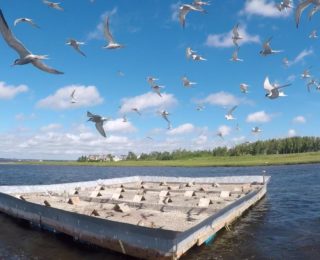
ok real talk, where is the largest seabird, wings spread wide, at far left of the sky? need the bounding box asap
[0,9,63,74]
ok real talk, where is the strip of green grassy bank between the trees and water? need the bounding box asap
[18,152,320,167]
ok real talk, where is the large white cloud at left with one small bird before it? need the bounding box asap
[37,85,103,110]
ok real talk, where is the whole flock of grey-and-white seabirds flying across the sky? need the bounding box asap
[0,0,320,138]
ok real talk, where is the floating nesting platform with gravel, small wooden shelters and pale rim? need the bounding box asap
[0,176,270,259]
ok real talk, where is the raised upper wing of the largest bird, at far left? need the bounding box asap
[0,9,31,58]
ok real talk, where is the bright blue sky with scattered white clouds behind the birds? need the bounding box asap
[0,0,320,159]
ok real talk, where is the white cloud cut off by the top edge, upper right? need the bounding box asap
[240,0,292,18]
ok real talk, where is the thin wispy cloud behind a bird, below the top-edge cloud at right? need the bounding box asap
[205,26,260,48]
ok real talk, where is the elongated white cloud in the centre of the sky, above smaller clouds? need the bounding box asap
[120,92,178,113]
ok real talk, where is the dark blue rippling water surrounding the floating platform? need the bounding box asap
[0,164,320,260]
